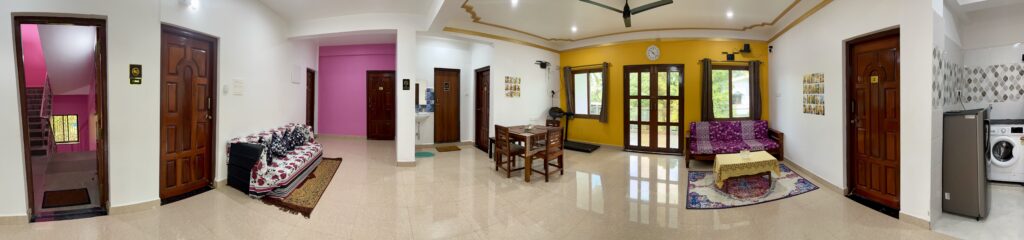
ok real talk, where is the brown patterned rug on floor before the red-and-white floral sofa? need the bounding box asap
[262,158,341,218]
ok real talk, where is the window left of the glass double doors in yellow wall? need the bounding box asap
[572,69,604,117]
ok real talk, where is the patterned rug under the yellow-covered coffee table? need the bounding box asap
[686,164,818,209]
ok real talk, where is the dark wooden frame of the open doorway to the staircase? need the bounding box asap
[11,15,111,218]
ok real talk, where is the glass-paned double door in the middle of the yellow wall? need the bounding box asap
[623,65,683,154]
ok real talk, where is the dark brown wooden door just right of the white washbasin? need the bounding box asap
[434,69,462,144]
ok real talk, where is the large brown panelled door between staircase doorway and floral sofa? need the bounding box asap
[160,26,216,199]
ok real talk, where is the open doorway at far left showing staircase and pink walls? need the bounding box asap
[13,16,110,222]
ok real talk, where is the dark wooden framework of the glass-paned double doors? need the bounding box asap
[618,64,687,155]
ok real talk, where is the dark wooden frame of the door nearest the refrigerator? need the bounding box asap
[843,27,903,202]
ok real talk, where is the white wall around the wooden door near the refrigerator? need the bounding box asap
[769,0,933,219]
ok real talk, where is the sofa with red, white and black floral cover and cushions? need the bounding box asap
[227,123,324,198]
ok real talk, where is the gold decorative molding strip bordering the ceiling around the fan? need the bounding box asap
[460,0,802,42]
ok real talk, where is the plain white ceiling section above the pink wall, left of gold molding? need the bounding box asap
[260,0,432,22]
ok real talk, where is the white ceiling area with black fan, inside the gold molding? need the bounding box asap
[465,0,806,39]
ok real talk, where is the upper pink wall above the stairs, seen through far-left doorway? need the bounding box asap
[22,25,46,87]
